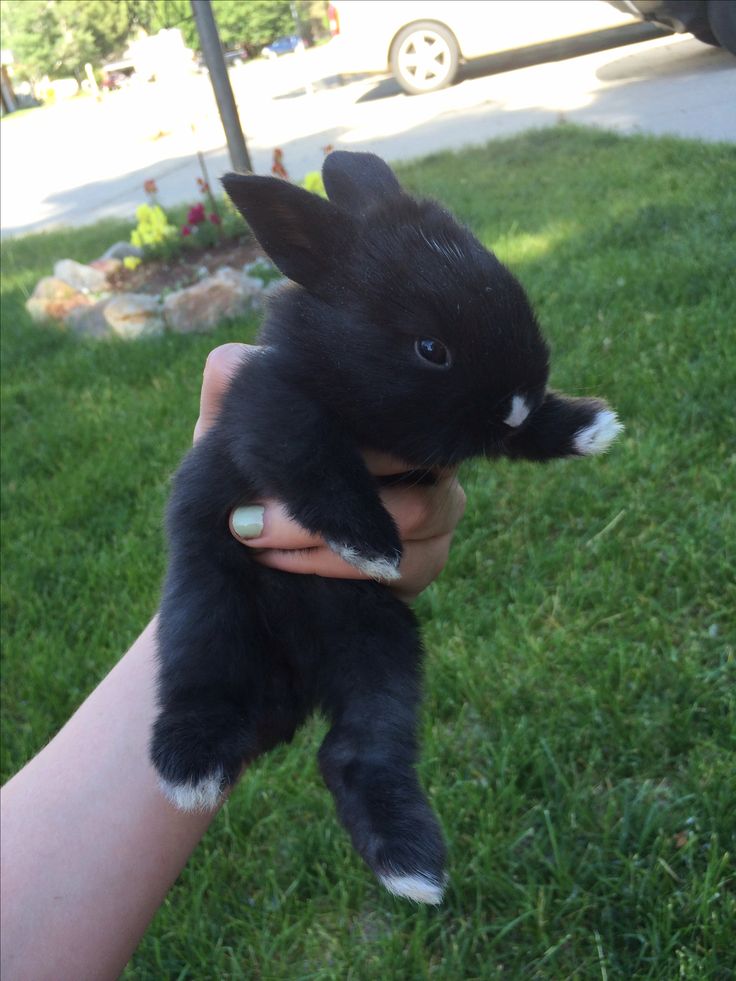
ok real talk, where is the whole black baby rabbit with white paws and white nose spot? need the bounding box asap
[151,152,621,903]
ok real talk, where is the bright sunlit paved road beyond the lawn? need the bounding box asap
[0,25,736,236]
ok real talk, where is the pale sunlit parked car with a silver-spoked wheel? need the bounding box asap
[328,0,632,94]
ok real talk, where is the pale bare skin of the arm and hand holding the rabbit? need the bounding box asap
[0,344,465,981]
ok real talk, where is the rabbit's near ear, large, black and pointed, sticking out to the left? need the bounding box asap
[222,174,352,289]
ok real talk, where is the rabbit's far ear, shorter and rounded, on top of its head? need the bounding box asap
[322,150,402,215]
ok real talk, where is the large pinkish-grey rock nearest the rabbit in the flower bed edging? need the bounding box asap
[164,266,254,334]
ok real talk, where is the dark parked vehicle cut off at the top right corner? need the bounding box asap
[608,0,736,54]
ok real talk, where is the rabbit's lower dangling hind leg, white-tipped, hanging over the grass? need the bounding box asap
[319,600,446,905]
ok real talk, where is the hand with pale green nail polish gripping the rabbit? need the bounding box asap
[194,344,465,601]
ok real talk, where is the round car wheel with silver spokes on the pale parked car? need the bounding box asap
[389,21,460,95]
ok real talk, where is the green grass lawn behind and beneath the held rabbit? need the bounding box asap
[2,127,736,981]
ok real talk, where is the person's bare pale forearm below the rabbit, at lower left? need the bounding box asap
[2,623,220,981]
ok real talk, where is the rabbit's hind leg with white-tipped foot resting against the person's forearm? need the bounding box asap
[150,564,279,810]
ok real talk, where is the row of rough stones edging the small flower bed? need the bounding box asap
[26,242,284,340]
